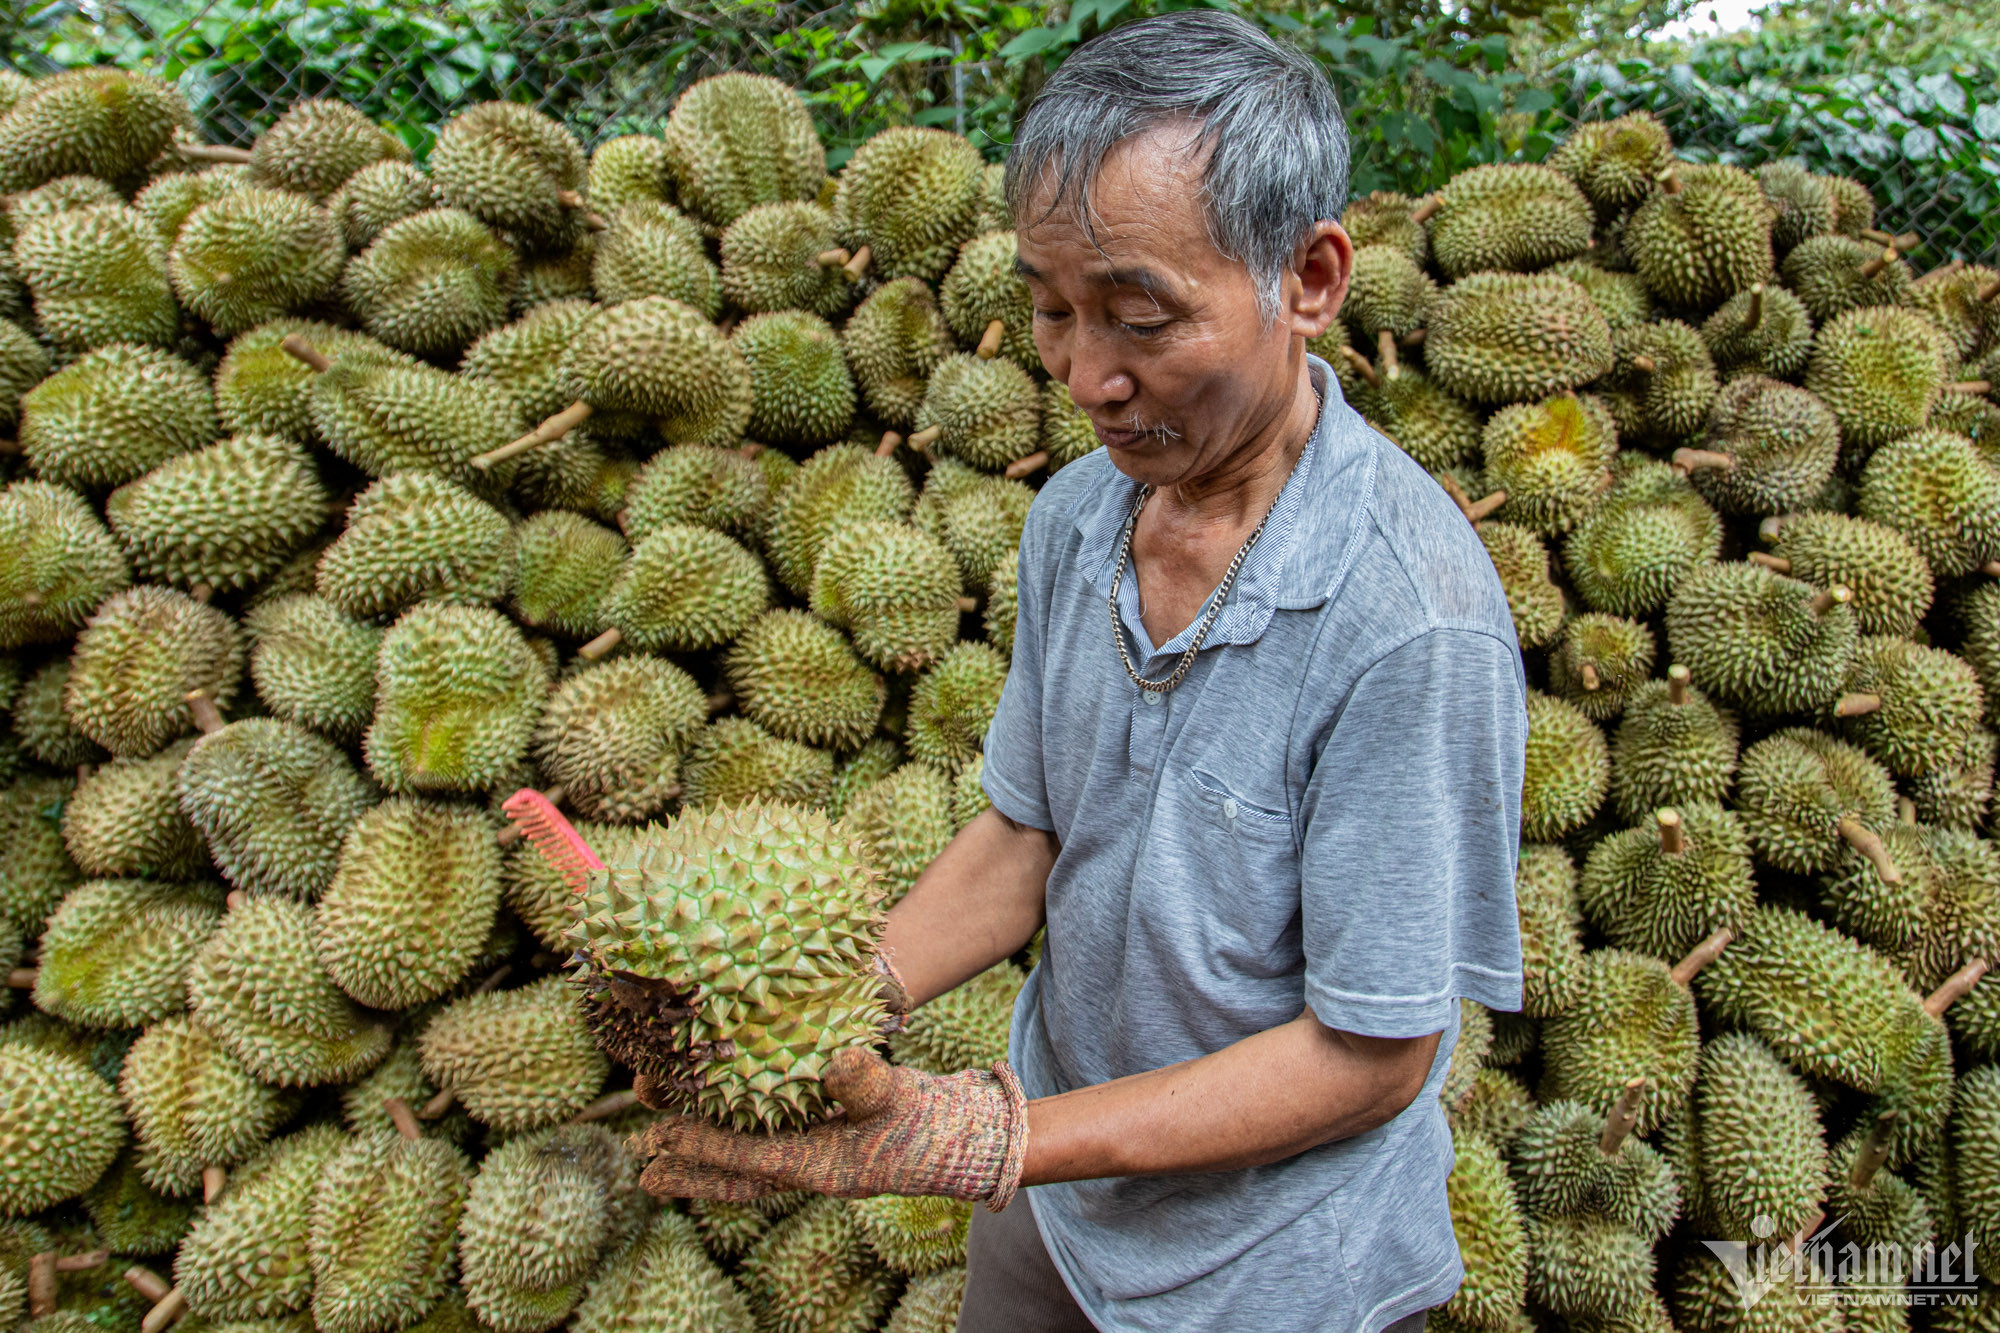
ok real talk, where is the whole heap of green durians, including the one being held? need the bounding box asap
[0,54,2000,1333]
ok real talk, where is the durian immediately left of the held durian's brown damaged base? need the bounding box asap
[416,977,610,1133]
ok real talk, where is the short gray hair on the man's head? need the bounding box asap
[1006,10,1348,326]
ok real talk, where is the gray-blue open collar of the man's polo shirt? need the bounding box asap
[1076,352,1378,656]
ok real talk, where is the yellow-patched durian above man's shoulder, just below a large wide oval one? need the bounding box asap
[1480,394,1618,536]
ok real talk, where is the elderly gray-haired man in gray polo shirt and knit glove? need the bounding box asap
[648,12,1526,1333]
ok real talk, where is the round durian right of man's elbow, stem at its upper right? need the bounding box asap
[1540,949,1700,1135]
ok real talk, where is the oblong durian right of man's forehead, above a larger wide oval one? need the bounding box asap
[1430,164,1592,280]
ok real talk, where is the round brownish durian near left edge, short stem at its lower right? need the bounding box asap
[62,584,244,757]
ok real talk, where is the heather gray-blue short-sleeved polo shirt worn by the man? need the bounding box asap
[984,358,1528,1333]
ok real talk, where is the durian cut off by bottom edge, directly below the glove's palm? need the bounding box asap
[740,1192,896,1333]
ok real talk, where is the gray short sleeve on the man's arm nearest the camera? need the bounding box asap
[1300,628,1528,1037]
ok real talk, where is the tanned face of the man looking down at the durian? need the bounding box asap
[1018,126,1344,488]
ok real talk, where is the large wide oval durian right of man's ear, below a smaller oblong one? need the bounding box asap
[1424,272,1612,404]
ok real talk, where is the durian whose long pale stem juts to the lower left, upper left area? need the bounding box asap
[562,296,752,444]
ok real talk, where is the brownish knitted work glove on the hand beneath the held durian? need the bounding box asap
[636,1049,1028,1213]
